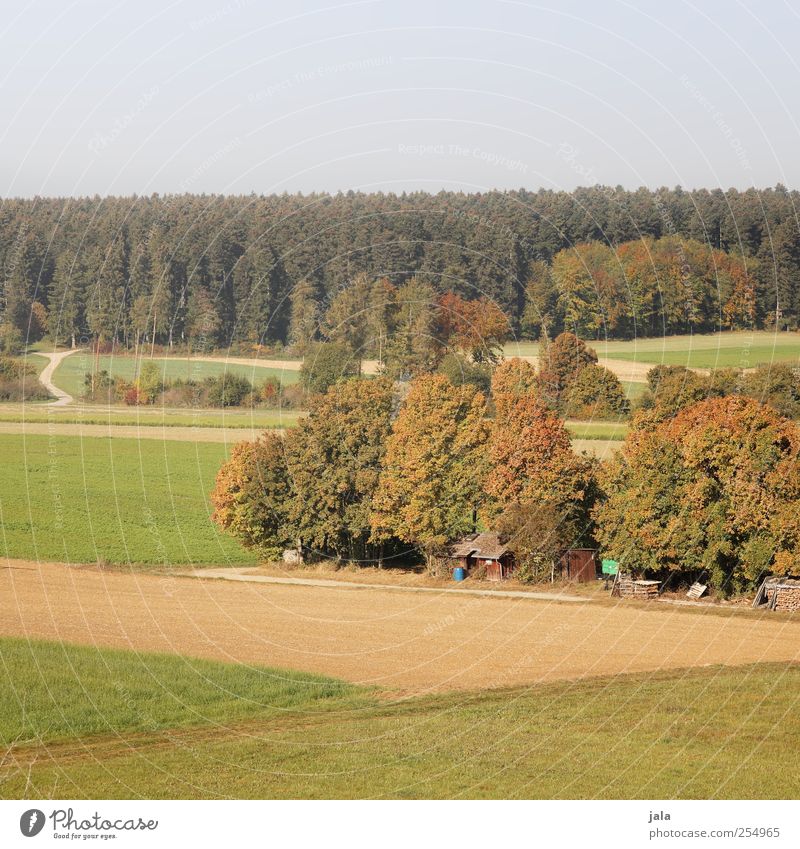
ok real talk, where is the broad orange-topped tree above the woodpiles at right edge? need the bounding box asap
[595,396,800,593]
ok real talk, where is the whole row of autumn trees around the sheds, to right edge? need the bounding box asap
[211,333,800,594]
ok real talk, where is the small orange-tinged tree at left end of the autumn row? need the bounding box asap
[211,431,294,557]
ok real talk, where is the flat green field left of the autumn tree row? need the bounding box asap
[0,434,256,565]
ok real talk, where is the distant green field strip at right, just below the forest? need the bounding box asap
[505,331,800,368]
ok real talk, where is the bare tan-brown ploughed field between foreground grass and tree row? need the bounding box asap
[0,561,800,693]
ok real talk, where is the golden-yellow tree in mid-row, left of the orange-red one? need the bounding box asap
[371,375,488,564]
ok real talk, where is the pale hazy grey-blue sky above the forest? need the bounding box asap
[0,0,800,197]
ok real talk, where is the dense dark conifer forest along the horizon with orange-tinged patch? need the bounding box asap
[0,186,800,349]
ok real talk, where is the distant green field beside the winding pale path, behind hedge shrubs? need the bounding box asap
[53,351,300,398]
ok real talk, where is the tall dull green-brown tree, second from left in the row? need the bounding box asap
[286,378,392,559]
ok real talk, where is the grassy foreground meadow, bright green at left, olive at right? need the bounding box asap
[0,639,800,799]
